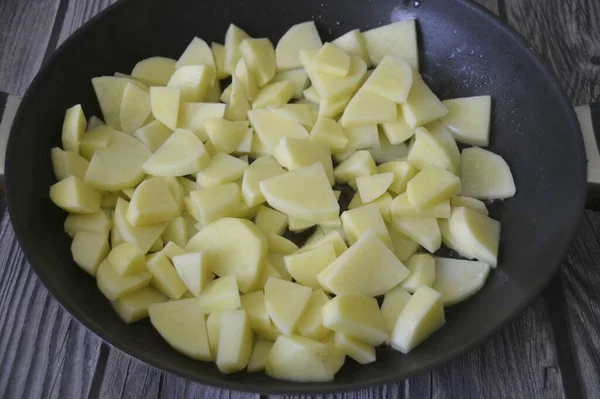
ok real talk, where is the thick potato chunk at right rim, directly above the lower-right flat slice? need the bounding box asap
[448,208,500,267]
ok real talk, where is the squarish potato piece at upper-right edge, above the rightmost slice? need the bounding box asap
[441,96,492,147]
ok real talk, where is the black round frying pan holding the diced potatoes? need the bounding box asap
[3,0,600,394]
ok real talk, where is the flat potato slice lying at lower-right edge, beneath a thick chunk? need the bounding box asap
[431,258,490,306]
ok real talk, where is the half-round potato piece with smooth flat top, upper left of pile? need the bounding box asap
[144,129,210,176]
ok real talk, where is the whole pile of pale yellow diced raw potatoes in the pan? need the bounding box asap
[50,20,516,381]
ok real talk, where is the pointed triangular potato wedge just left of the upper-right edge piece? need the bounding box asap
[401,72,448,128]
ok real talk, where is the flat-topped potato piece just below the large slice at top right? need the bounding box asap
[363,55,413,104]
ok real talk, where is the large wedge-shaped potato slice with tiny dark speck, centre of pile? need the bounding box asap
[259,163,340,222]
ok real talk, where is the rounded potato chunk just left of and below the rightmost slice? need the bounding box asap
[406,168,461,209]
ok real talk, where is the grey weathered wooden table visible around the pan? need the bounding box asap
[0,0,600,399]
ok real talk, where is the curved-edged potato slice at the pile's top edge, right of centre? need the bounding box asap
[275,21,323,71]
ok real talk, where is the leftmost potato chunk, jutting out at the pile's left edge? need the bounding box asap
[50,176,102,213]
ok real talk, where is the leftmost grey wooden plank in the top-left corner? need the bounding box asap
[0,0,59,95]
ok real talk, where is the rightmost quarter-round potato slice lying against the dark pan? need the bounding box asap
[460,147,517,199]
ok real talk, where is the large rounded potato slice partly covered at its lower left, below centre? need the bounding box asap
[185,218,268,293]
